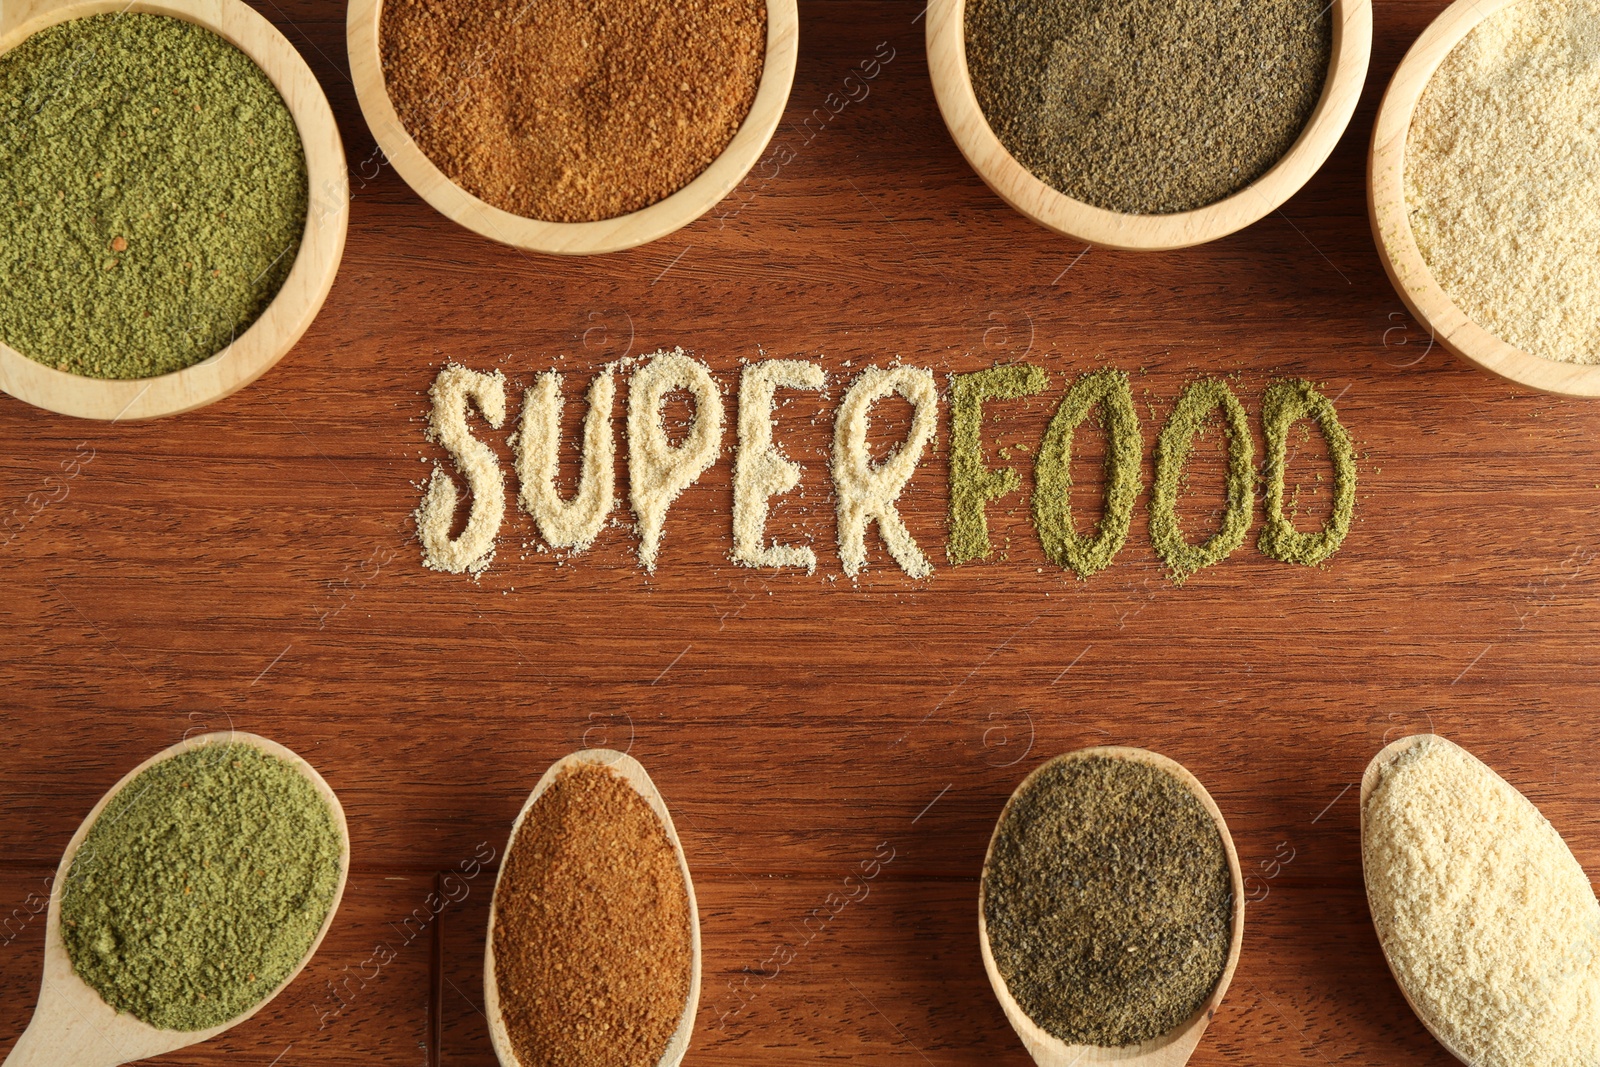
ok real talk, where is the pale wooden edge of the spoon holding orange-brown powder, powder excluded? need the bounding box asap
[483,749,701,1067]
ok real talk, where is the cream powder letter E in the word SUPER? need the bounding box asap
[733,360,827,574]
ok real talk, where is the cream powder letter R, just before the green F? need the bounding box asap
[834,366,939,577]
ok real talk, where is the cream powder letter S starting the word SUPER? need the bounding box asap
[416,363,506,574]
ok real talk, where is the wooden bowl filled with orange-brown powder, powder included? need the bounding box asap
[347,0,798,254]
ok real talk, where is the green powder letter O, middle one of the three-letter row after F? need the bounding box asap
[1150,378,1254,585]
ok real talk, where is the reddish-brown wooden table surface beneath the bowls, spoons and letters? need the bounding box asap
[0,0,1600,1067]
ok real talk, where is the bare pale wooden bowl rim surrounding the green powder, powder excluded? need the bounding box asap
[0,0,350,422]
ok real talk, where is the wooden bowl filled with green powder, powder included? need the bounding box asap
[0,0,349,419]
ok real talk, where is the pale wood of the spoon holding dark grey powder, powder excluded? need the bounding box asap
[978,745,1245,1067]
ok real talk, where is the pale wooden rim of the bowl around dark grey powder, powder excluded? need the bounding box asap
[928,0,1373,251]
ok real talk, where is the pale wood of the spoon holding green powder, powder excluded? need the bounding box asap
[5,731,350,1067]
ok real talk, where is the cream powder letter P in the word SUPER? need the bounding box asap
[627,349,722,571]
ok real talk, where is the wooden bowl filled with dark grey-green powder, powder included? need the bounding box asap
[928,0,1373,250]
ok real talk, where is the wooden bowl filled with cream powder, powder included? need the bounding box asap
[1368,0,1600,397]
